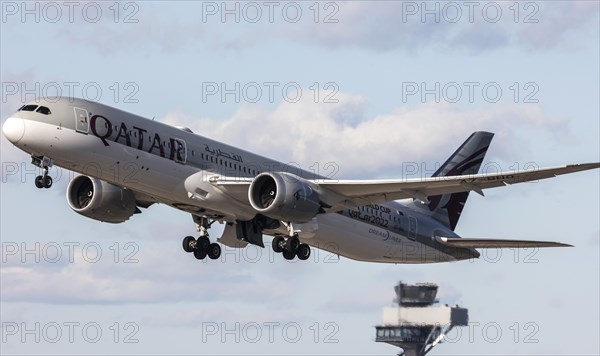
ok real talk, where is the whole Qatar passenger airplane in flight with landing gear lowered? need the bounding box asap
[2,97,600,263]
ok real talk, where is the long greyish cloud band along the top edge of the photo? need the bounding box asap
[35,1,599,55]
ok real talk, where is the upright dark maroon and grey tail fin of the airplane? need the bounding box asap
[415,131,494,230]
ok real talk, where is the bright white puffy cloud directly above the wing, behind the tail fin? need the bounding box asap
[163,89,570,178]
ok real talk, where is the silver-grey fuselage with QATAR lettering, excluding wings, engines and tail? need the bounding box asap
[3,99,463,263]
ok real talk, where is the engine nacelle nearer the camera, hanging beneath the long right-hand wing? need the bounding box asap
[248,172,326,223]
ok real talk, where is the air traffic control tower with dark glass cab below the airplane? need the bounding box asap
[375,282,469,356]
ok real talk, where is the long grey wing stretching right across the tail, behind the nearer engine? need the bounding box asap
[210,163,600,211]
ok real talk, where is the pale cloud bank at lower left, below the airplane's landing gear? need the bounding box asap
[0,238,294,304]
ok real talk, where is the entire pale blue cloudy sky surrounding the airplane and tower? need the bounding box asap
[0,1,600,355]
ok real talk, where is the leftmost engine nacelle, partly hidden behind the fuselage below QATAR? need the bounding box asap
[67,176,137,224]
